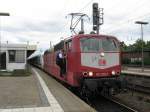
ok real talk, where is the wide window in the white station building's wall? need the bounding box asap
[9,50,25,63]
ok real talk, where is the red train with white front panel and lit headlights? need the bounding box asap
[28,34,121,94]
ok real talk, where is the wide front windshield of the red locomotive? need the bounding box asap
[80,37,118,52]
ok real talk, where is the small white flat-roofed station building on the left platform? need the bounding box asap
[0,44,36,71]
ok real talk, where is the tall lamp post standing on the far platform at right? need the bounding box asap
[135,21,148,72]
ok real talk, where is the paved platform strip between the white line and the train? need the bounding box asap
[36,69,95,112]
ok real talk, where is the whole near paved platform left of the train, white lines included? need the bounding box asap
[0,68,95,112]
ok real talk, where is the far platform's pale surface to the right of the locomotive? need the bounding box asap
[121,67,150,77]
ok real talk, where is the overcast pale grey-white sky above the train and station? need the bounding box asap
[0,0,150,49]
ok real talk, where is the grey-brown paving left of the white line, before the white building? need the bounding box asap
[0,72,45,108]
